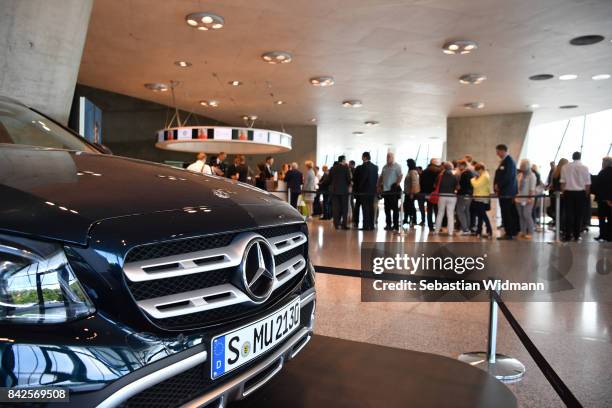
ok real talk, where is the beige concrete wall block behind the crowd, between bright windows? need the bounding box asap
[446,112,532,170]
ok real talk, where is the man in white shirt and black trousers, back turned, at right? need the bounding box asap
[560,152,591,241]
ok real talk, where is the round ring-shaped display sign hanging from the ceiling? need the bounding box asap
[155,126,292,154]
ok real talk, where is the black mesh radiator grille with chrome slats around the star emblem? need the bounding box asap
[123,224,308,329]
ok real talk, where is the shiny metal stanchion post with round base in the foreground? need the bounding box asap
[459,291,525,382]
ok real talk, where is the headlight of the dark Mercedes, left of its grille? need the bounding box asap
[0,239,95,324]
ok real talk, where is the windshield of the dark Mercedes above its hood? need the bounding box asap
[0,99,98,153]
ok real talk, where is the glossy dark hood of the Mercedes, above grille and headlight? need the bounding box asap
[0,146,300,245]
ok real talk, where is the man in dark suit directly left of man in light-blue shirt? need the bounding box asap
[353,152,378,231]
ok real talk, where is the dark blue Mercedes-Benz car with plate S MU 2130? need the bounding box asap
[0,98,315,408]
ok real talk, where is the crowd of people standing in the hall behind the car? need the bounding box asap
[188,144,612,241]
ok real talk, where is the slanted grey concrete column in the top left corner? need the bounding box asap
[0,0,93,123]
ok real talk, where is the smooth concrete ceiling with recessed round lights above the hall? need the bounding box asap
[79,0,612,149]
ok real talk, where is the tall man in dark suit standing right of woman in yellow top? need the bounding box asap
[493,144,519,239]
